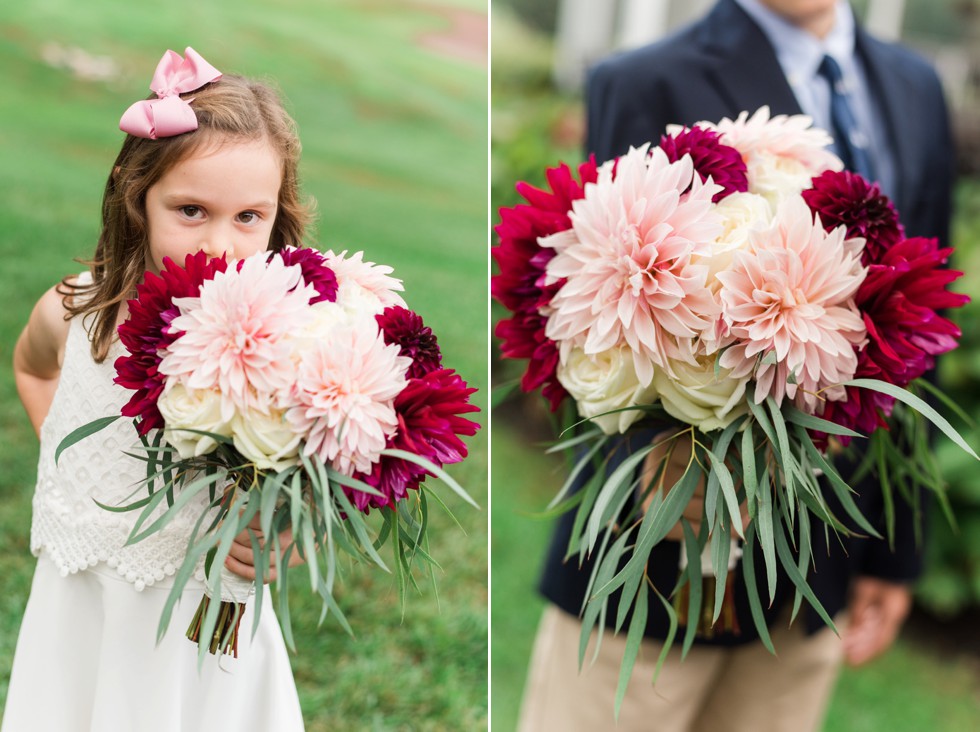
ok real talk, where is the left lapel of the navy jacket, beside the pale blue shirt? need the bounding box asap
[701,0,801,116]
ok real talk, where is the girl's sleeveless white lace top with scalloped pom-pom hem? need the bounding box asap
[31,273,207,590]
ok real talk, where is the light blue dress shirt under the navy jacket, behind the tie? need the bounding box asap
[735,0,896,196]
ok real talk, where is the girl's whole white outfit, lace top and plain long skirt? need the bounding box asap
[2,276,303,732]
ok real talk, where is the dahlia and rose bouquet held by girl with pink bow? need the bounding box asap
[58,248,478,658]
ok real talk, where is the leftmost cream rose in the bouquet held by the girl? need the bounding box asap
[157,382,231,459]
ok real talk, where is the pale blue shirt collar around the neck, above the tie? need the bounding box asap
[735,0,854,87]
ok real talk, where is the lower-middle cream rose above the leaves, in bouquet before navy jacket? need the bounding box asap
[653,356,749,432]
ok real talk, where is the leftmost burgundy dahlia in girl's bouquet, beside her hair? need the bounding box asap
[114,252,228,435]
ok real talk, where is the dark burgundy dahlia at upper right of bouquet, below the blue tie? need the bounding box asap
[803,170,905,265]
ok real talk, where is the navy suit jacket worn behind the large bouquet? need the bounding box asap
[540,0,954,645]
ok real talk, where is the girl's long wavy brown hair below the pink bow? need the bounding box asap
[61,75,312,363]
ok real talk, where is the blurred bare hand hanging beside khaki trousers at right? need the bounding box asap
[843,577,912,666]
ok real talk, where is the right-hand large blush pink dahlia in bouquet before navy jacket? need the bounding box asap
[718,197,866,414]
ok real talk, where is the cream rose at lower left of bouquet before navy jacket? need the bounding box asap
[557,347,657,435]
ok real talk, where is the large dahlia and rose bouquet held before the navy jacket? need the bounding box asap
[492,108,976,708]
